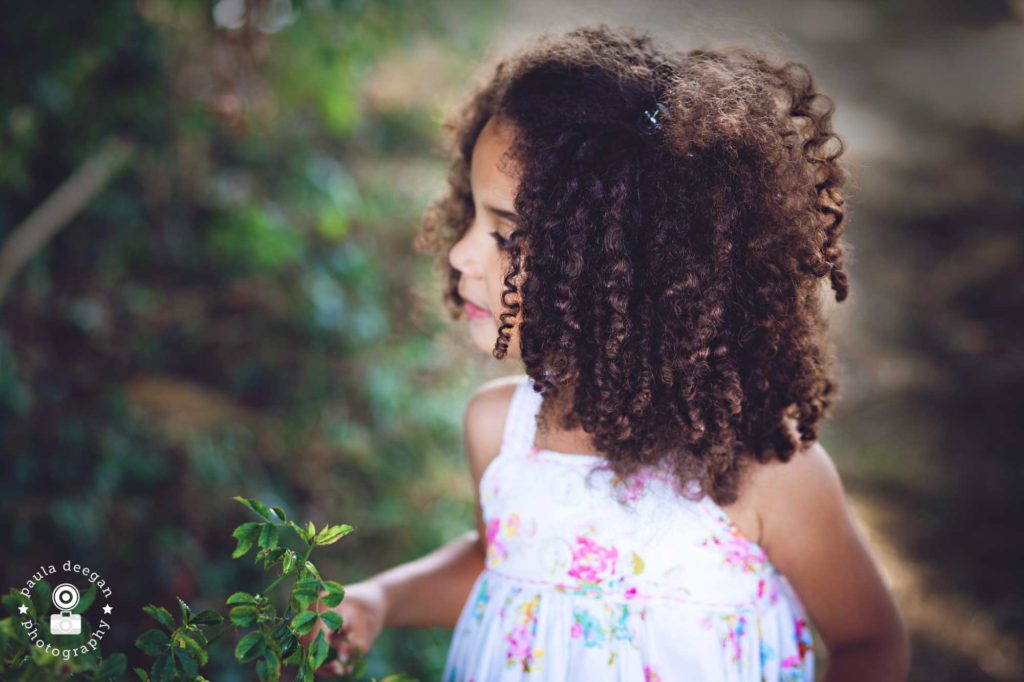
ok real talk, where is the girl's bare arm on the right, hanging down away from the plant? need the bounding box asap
[751,442,910,682]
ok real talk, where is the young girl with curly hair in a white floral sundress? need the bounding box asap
[313,25,909,682]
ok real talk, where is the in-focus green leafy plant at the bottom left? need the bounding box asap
[0,497,413,682]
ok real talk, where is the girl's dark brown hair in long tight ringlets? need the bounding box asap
[414,24,849,504]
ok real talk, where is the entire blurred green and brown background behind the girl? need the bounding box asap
[0,0,1024,681]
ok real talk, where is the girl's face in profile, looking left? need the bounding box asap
[449,118,520,357]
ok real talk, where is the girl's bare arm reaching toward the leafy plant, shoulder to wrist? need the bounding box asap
[368,377,519,628]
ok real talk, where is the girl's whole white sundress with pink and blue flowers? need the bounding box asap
[442,377,814,682]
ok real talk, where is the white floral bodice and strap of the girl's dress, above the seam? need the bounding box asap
[480,378,779,607]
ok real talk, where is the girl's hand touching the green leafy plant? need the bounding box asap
[300,581,387,676]
